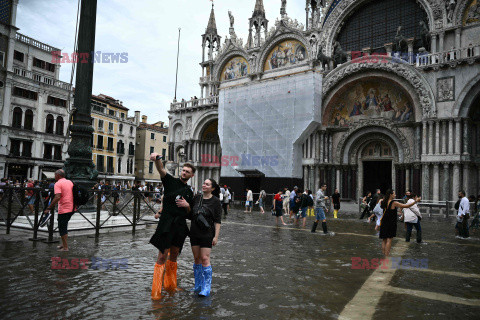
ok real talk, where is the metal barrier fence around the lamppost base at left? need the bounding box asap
[0,187,161,241]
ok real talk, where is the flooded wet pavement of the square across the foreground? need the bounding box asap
[0,211,480,320]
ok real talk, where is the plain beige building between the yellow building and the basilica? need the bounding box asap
[135,116,168,186]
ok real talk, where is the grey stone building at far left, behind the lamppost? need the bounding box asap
[0,0,72,180]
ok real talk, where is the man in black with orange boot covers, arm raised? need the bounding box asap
[150,153,195,300]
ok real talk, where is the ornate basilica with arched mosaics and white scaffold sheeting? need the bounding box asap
[169,0,480,200]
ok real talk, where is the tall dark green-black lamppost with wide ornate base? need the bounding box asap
[65,0,98,189]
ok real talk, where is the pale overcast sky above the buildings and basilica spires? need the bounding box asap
[16,0,305,124]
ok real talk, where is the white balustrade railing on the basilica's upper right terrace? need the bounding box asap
[416,45,480,67]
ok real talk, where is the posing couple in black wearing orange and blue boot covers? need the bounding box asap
[150,153,222,300]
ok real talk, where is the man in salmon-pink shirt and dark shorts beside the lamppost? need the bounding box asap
[44,170,75,251]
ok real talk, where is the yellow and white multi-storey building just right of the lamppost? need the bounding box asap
[92,94,140,185]
